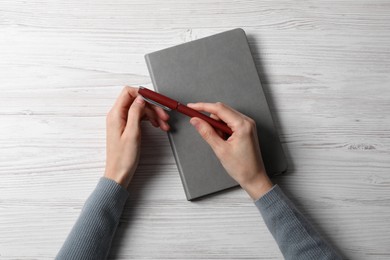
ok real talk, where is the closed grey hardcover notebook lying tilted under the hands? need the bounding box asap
[145,29,287,200]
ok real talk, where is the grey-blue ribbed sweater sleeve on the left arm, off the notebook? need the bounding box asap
[56,177,129,259]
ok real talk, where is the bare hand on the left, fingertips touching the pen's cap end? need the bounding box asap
[104,87,169,188]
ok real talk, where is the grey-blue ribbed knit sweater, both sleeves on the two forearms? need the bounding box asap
[56,177,341,260]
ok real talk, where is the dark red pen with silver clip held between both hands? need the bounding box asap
[138,87,233,135]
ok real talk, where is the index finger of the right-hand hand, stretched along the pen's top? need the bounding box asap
[187,102,243,130]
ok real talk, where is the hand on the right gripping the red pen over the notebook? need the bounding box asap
[187,102,273,200]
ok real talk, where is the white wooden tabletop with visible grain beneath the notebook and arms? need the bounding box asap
[0,0,390,259]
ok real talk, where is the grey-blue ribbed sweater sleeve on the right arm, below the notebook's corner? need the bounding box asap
[255,185,341,259]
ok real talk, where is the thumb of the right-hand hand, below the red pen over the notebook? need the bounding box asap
[190,117,224,153]
